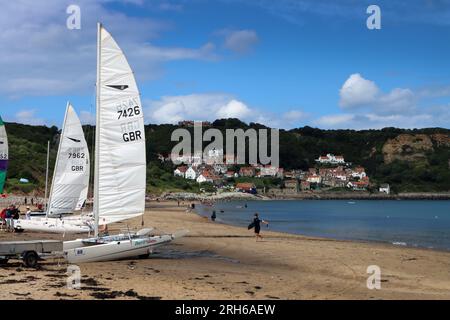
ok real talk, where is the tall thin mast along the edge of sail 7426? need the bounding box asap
[94,23,102,237]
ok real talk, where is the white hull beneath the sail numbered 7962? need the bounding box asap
[14,218,92,234]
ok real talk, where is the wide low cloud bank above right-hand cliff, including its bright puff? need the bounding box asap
[312,73,450,129]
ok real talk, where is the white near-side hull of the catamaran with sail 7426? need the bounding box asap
[64,235,173,264]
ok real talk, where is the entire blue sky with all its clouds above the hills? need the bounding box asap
[0,0,450,129]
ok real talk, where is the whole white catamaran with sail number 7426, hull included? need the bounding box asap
[64,24,183,263]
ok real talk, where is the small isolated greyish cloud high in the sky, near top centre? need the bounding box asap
[216,29,259,54]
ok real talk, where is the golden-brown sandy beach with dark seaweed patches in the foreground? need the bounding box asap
[0,202,450,299]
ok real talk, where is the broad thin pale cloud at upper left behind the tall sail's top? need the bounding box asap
[0,0,216,97]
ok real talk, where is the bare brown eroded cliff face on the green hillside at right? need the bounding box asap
[382,134,450,163]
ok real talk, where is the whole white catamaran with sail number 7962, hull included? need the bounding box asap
[15,103,93,233]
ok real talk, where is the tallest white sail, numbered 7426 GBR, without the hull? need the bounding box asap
[94,26,146,226]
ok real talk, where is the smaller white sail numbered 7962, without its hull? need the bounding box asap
[47,103,90,216]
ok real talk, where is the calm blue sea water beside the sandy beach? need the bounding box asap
[197,200,450,250]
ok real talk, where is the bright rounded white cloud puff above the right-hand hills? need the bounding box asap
[339,73,379,108]
